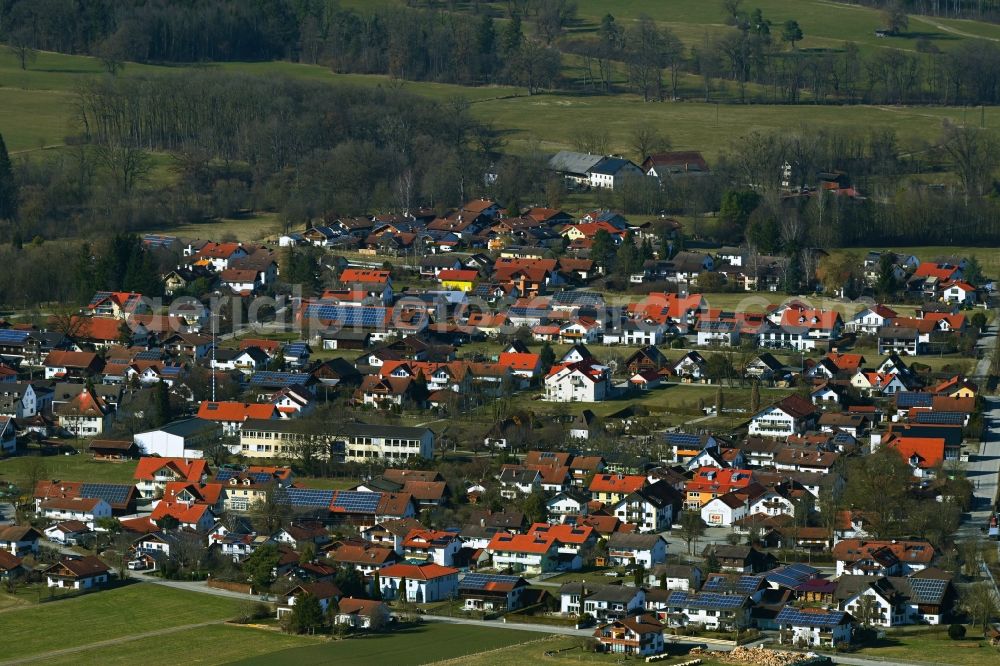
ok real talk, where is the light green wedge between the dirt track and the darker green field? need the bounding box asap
[45,620,319,666]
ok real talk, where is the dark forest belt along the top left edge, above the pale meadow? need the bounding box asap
[0,0,561,92]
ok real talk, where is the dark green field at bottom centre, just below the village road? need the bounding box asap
[237,623,539,666]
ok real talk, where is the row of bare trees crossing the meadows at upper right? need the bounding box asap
[560,9,1000,105]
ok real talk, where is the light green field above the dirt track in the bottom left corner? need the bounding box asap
[2,583,239,663]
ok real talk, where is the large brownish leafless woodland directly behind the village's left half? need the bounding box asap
[0,71,500,245]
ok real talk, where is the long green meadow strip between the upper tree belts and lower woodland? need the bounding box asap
[0,45,1000,159]
